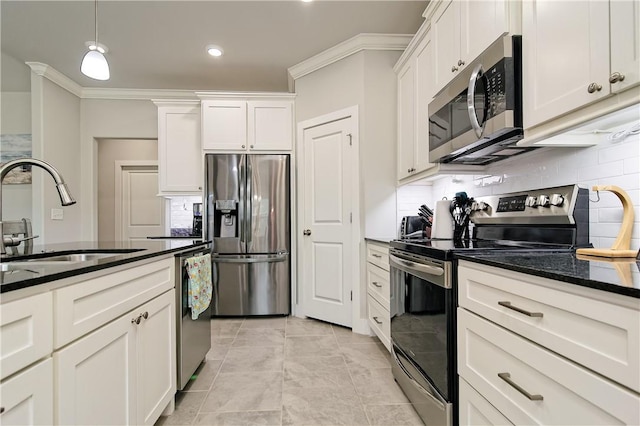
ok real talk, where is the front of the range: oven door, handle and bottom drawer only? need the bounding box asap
[389,248,457,425]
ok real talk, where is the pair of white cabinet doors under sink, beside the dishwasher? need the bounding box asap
[53,290,176,425]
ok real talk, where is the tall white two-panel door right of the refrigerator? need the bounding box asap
[299,116,358,327]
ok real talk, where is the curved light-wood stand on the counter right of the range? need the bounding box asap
[576,185,638,258]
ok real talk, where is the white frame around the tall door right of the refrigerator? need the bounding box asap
[298,105,370,334]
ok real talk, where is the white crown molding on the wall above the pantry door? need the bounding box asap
[287,33,413,80]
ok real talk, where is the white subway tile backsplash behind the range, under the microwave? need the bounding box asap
[432,125,640,250]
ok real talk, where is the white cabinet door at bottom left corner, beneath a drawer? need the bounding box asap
[0,358,53,425]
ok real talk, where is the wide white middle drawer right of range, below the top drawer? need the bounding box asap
[458,309,640,425]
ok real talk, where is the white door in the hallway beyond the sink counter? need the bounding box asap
[116,162,166,241]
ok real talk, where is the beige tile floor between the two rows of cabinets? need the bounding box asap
[156,317,422,426]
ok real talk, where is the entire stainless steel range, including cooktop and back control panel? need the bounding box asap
[389,185,589,425]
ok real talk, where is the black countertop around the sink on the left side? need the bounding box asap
[0,239,209,293]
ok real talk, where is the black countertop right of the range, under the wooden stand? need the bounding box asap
[456,252,640,298]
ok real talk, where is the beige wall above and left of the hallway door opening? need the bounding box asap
[80,99,158,241]
